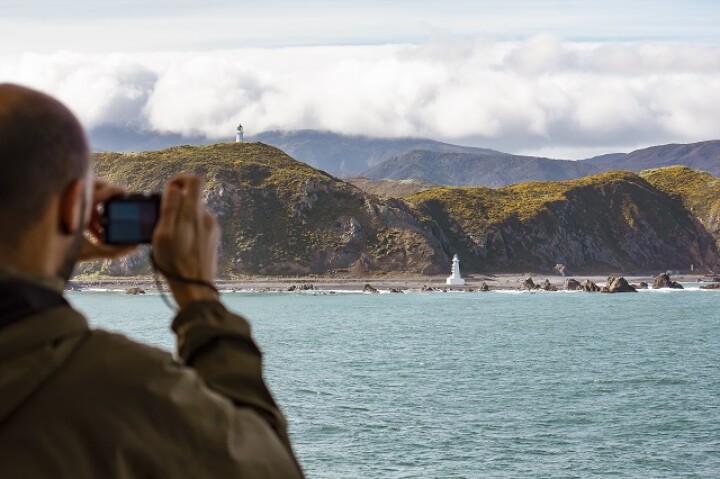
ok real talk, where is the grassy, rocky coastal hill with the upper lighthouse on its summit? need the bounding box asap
[92,143,449,276]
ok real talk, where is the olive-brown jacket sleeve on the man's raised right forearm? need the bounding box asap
[172,301,300,470]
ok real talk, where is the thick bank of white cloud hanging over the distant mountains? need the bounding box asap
[0,34,720,158]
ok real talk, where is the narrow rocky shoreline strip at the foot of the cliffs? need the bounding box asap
[67,273,712,294]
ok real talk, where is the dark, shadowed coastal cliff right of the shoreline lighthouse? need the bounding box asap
[406,171,720,272]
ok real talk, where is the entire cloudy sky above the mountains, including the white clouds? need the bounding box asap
[0,0,720,158]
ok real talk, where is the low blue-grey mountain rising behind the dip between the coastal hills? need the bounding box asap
[362,150,603,188]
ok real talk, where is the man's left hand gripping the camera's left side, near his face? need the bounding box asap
[79,180,137,261]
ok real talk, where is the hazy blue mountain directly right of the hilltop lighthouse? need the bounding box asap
[249,130,501,177]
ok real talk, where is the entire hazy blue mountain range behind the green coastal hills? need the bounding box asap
[89,126,720,187]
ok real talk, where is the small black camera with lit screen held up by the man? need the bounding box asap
[102,193,161,245]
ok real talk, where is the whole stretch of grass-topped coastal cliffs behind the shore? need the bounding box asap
[88,143,720,277]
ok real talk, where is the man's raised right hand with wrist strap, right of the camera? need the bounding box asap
[152,175,220,309]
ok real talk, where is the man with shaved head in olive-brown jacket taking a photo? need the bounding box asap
[0,84,302,478]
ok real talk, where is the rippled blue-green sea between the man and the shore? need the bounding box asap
[69,289,720,479]
